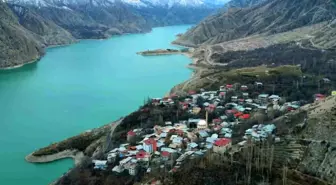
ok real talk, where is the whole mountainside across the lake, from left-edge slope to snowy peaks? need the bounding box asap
[0,0,226,68]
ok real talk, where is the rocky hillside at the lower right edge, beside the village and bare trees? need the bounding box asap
[276,96,336,184]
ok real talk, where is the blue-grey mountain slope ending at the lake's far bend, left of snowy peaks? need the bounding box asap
[9,0,150,39]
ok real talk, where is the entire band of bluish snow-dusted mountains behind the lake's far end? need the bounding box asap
[7,0,225,39]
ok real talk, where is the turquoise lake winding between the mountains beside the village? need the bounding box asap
[0,25,192,185]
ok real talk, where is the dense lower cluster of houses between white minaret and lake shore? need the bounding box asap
[93,119,232,175]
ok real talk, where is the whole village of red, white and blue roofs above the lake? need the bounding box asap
[92,82,325,181]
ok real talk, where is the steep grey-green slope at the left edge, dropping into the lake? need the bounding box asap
[0,2,43,68]
